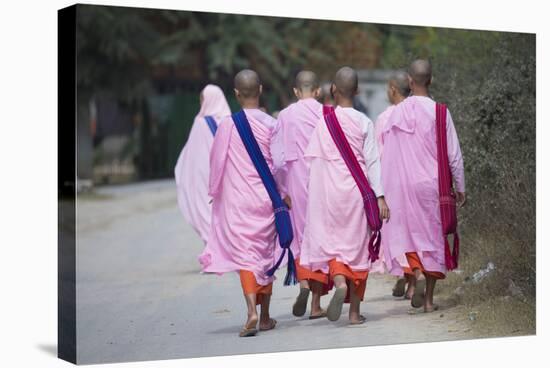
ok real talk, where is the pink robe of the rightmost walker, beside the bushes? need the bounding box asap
[382,96,464,275]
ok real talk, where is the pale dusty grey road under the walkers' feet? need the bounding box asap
[77,180,468,363]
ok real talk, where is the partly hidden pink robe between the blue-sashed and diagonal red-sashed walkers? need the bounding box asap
[271,98,323,258]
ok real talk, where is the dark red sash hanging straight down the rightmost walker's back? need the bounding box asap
[435,103,460,270]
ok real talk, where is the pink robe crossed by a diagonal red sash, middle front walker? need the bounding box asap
[300,107,381,273]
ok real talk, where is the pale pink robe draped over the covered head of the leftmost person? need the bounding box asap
[174,84,231,243]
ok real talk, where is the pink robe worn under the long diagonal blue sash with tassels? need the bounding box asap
[199,109,278,285]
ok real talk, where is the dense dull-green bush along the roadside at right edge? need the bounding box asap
[458,33,536,296]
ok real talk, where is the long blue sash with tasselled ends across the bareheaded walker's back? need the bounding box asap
[232,110,296,285]
